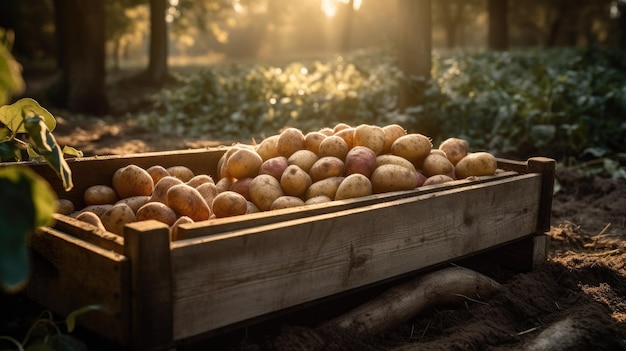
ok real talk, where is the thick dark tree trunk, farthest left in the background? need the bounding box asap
[54,0,109,115]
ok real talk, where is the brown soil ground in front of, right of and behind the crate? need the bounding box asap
[4,75,626,351]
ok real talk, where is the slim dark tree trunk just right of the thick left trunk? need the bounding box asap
[145,0,168,86]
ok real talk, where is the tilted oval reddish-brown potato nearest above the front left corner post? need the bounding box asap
[167,184,211,222]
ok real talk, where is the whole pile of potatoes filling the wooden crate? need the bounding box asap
[59,123,497,240]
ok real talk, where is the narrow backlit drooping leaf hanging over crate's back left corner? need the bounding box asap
[24,116,74,191]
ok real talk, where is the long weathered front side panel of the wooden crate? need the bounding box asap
[172,175,541,339]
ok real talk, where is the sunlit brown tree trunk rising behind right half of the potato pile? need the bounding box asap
[398,0,432,111]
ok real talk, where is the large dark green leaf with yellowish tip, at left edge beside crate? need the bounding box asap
[0,166,57,293]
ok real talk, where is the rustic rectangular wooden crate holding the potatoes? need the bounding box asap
[9,148,555,350]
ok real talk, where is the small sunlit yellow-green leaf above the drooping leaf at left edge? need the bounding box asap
[0,98,56,134]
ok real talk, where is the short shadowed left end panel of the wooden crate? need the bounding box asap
[25,228,130,345]
